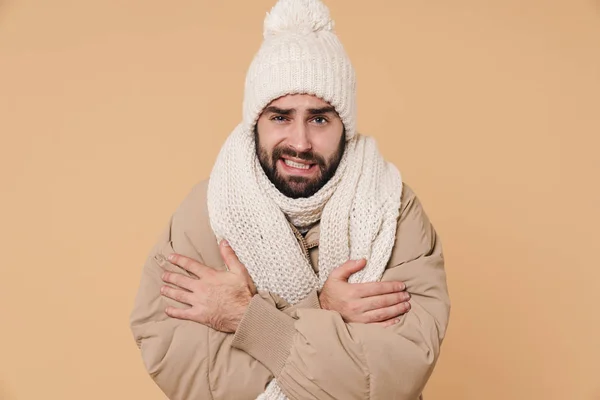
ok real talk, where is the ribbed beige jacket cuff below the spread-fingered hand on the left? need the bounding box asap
[231,295,296,377]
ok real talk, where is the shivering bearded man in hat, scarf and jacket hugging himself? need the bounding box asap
[131,0,450,400]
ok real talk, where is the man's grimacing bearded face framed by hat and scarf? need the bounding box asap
[256,94,346,199]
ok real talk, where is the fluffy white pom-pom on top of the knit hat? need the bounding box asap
[263,0,334,38]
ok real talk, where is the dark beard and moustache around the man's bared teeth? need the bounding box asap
[254,129,346,199]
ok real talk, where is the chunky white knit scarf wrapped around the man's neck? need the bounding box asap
[207,125,402,400]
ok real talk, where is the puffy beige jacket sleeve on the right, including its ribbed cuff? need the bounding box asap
[233,187,450,400]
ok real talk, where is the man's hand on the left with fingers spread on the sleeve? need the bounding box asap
[161,240,256,333]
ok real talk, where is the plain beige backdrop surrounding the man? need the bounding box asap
[0,0,600,400]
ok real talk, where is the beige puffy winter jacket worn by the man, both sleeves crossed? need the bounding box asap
[130,181,450,400]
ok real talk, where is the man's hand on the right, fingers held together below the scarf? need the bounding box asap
[319,259,410,327]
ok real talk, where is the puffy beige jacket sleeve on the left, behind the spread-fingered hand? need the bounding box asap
[130,184,318,400]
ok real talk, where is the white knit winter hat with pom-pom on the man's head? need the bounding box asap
[243,0,356,140]
